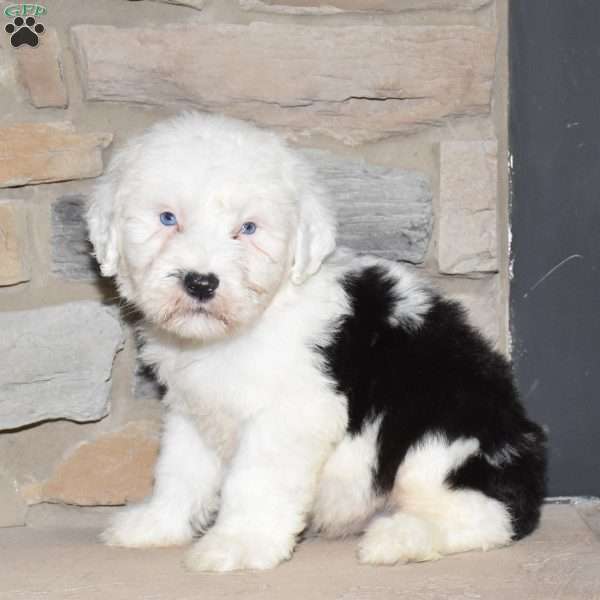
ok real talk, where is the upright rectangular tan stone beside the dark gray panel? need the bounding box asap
[438,140,498,274]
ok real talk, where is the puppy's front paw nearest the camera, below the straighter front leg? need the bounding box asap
[185,530,294,571]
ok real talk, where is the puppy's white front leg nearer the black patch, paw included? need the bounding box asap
[186,414,332,571]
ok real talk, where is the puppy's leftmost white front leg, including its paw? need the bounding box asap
[101,413,221,548]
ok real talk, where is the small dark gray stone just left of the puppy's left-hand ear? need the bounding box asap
[52,194,100,280]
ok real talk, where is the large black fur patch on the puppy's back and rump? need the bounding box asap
[319,267,545,539]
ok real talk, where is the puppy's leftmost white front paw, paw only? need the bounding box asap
[100,504,192,548]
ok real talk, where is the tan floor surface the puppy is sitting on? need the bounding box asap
[0,502,600,600]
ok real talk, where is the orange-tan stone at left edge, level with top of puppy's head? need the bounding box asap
[0,122,112,187]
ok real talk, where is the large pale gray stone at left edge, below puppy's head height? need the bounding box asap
[0,301,124,429]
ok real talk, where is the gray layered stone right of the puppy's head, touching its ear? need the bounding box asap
[304,150,433,263]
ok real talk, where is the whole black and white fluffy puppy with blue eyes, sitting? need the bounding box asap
[87,114,545,571]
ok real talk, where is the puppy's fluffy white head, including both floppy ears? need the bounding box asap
[87,113,335,339]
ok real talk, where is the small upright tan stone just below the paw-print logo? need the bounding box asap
[15,28,69,108]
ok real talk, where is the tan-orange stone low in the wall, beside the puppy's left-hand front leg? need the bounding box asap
[38,421,158,506]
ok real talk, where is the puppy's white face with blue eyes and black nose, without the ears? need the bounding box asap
[121,162,296,338]
